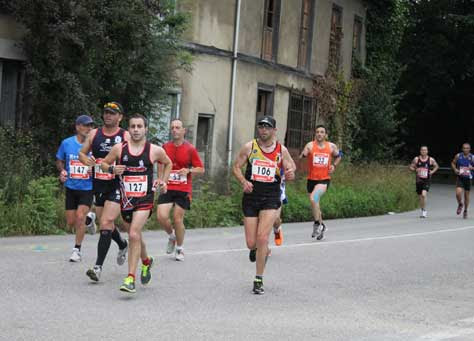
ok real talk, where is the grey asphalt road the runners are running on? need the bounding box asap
[0,186,474,341]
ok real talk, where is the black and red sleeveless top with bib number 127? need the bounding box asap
[119,142,153,198]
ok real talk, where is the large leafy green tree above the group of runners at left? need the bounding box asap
[0,0,189,169]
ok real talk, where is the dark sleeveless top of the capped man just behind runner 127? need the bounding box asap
[91,128,125,193]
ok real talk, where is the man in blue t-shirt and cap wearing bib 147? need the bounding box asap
[56,115,95,262]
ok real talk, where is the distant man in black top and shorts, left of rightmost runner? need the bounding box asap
[410,146,439,218]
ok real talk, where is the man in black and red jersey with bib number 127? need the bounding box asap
[101,114,172,293]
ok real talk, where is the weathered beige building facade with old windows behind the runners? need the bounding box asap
[171,0,366,174]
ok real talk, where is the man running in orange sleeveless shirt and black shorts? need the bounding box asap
[300,124,341,240]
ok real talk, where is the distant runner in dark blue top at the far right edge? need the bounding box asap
[451,143,474,219]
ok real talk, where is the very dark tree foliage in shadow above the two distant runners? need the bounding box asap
[399,0,474,164]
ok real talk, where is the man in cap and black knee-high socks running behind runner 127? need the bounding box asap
[79,102,130,281]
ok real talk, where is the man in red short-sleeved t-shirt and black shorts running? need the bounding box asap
[156,119,204,261]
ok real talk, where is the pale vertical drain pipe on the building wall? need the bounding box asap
[227,0,241,168]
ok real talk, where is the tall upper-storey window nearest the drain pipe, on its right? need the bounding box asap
[262,0,281,61]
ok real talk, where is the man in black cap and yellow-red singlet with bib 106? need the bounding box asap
[233,116,295,294]
